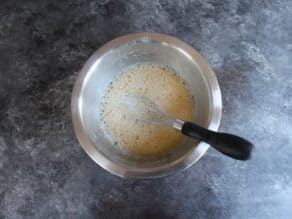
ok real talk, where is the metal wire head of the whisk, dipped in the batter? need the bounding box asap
[120,96,176,127]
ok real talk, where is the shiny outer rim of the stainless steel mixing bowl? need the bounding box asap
[71,32,222,178]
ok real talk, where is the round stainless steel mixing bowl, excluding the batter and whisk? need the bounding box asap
[71,33,222,178]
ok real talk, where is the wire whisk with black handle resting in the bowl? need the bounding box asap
[120,96,253,160]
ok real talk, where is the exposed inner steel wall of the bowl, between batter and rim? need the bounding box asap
[78,37,212,176]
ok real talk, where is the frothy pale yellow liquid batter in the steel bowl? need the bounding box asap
[101,64,194,156]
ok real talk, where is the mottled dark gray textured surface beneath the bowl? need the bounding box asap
[0,0,292,218]
